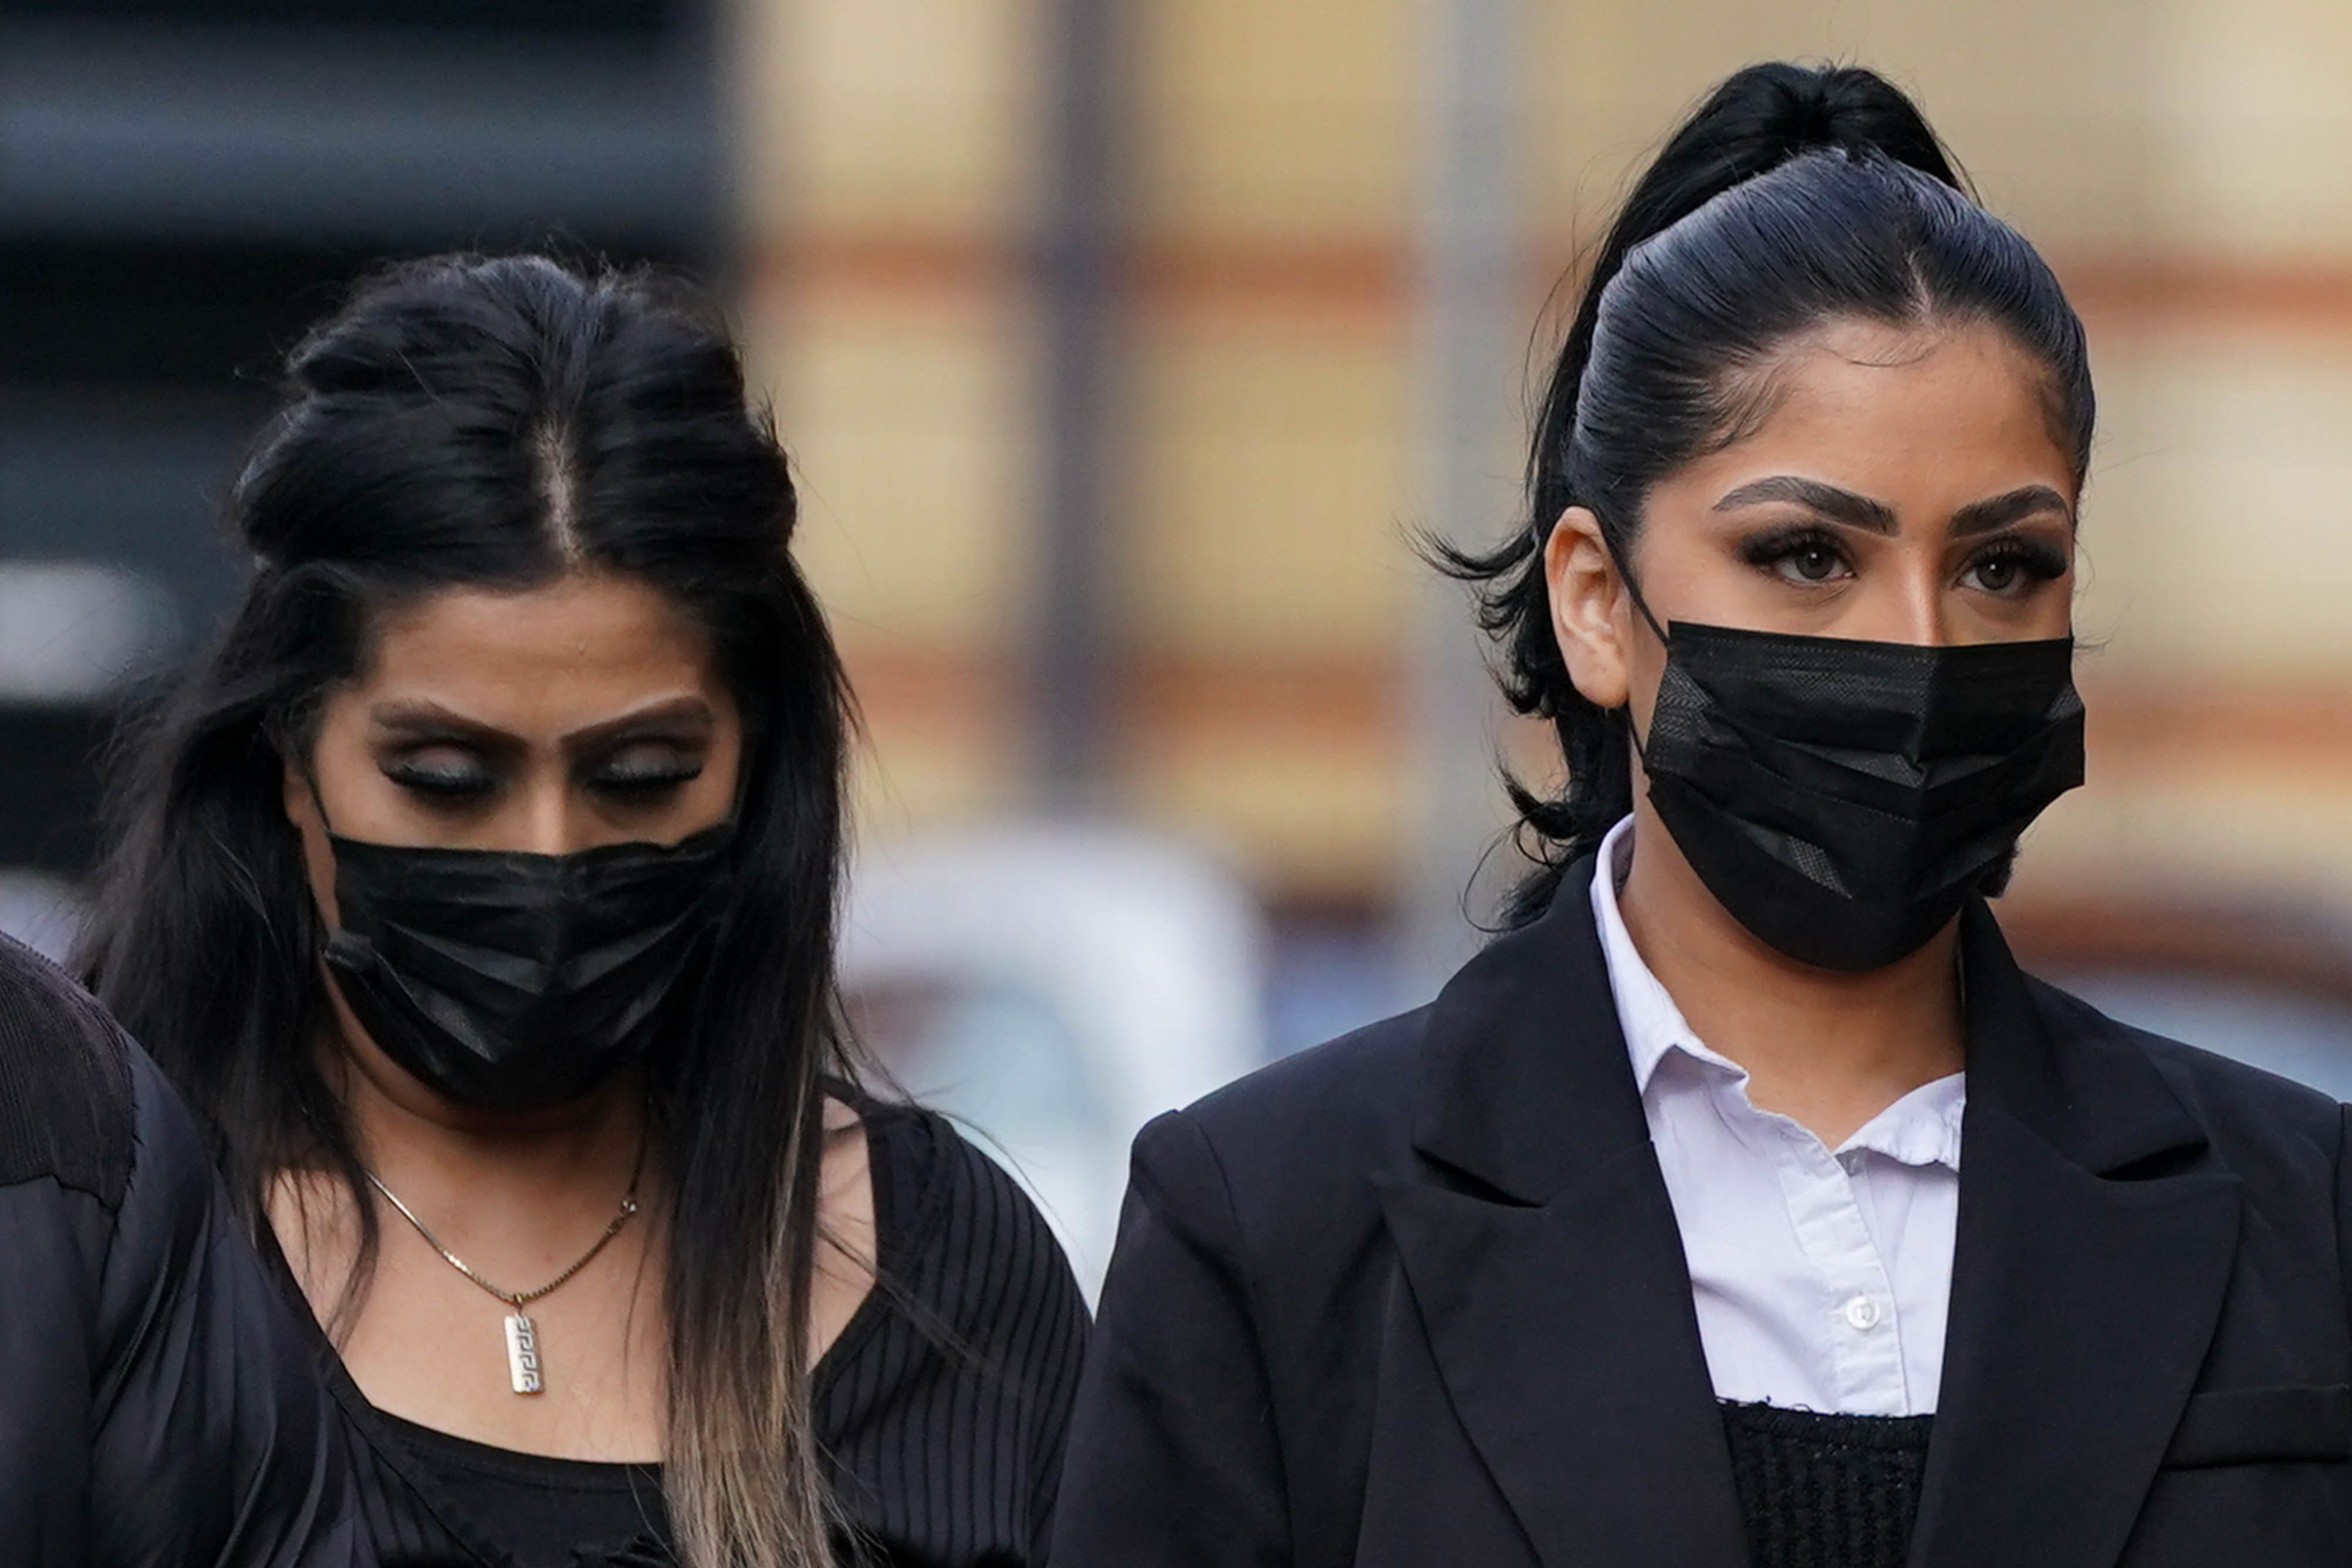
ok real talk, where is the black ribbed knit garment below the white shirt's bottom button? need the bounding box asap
[1724,1401,1936,1568]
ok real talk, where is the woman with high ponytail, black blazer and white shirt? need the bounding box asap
[1054,66,2352,1568]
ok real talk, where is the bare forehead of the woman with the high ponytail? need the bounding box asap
[1682,322,2074,510]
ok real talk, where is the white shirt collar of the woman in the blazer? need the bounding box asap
[1592,816,1969,1171]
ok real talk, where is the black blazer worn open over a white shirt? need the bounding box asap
[1054,860,2352,1568]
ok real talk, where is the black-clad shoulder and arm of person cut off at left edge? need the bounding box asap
[0,938,371,1568]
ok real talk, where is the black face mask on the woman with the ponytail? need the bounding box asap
[1637,607,2084,971]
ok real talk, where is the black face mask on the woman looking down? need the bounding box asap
[327,823,734,1110]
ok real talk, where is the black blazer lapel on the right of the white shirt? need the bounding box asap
[1910,907,2239,1568]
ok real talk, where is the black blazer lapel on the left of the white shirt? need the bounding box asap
[1383,860,1745,1568]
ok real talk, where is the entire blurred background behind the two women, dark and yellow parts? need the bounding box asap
[0,0,2352,1276]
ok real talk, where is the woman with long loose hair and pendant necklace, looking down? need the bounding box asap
[80,256,1084,1568]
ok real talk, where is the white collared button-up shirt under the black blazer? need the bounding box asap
[1592,818,1966,1415]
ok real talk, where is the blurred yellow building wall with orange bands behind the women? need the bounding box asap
[736,0,2352,978]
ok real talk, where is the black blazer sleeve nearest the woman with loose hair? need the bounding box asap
[1054,1112,1291,1568]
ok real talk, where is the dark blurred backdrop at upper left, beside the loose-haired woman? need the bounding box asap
[0,0,731,931]
